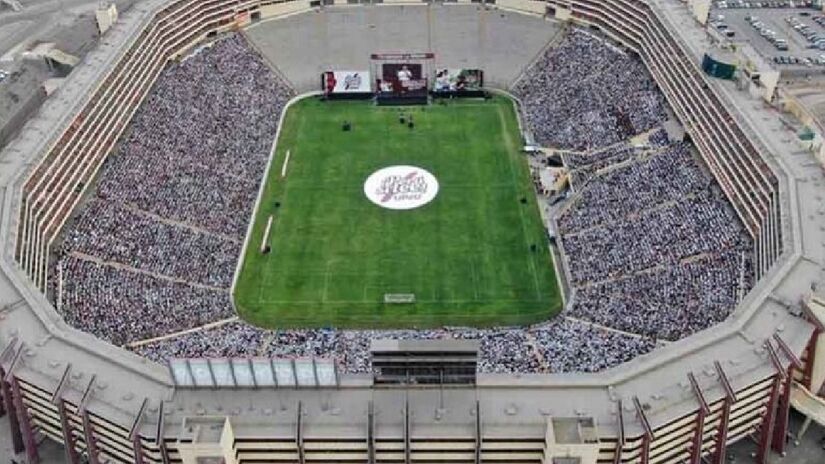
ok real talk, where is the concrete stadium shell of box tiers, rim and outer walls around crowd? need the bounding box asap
[0,0,825,464]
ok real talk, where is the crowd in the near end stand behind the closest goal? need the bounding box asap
[133,319,655,374]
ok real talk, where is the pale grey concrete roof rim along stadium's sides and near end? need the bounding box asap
[0,0,825,437]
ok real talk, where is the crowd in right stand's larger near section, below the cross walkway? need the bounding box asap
[557,140,752,340]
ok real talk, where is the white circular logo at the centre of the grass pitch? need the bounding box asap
[364,166,438,209]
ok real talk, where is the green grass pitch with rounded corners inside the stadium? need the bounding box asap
[235,97,561,328]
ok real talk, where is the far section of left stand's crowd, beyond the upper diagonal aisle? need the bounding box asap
[98,35,292,240]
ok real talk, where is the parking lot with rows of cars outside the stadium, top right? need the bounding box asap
[708,7,825,71]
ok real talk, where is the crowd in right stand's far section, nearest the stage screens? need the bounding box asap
[513,29,667,150]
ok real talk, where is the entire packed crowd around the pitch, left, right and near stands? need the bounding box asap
[50,30,750,373]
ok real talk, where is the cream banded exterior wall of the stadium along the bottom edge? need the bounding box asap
[4,368,784,464]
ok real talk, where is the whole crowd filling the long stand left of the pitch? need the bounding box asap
[51,35,292,344]
